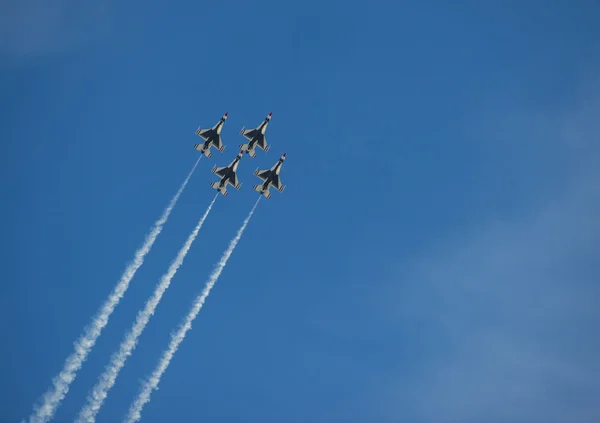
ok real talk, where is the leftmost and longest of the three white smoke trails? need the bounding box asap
[29,156,202,423]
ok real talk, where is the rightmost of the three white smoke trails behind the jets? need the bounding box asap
[124,197,261,423]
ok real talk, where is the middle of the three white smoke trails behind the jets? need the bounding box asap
[77,193,219,423]
